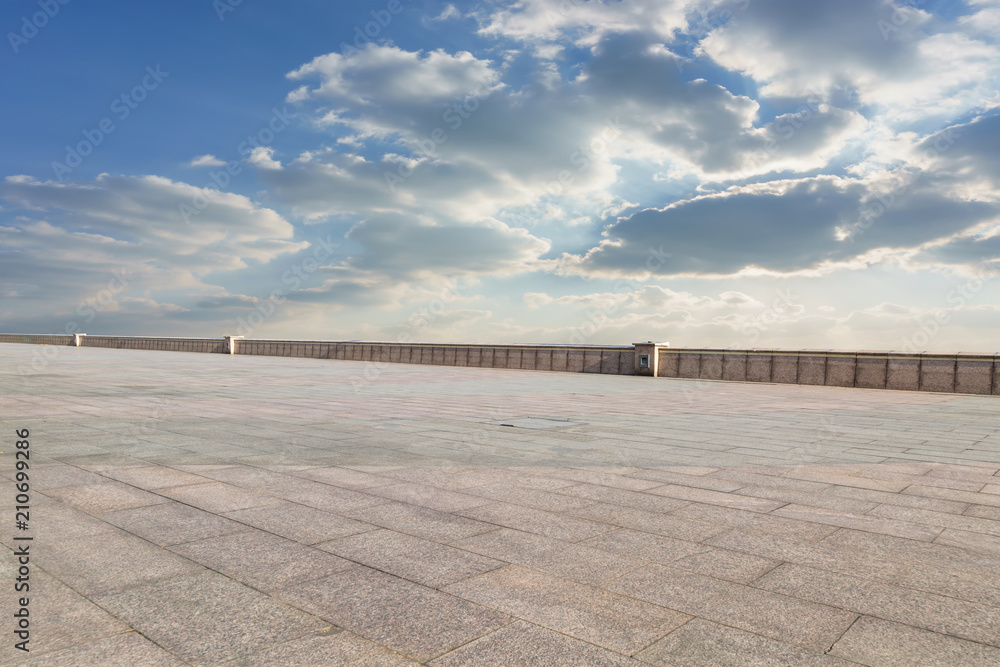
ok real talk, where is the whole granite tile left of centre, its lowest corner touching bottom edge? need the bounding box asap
[277,565,511,661]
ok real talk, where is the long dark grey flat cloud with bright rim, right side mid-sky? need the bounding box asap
[566,170,1000,275]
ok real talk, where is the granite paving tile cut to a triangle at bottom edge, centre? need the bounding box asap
[428,621,641,667]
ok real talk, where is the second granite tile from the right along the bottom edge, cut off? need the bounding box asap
[636,618,854,667]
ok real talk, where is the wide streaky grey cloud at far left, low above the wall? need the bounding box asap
[0,174,308,331]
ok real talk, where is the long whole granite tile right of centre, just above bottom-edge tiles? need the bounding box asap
[606,565,857,651]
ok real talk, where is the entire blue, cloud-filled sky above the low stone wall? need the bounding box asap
[0,0,1000,352]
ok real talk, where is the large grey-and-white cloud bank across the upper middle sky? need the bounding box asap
[272,33,863,243]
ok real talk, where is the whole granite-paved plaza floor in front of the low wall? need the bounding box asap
[0,344,1000,666]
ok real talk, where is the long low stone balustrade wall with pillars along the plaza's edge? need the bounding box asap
[0,334,1000,396]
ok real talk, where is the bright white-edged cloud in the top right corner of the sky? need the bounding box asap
[699,0,1000,120]
